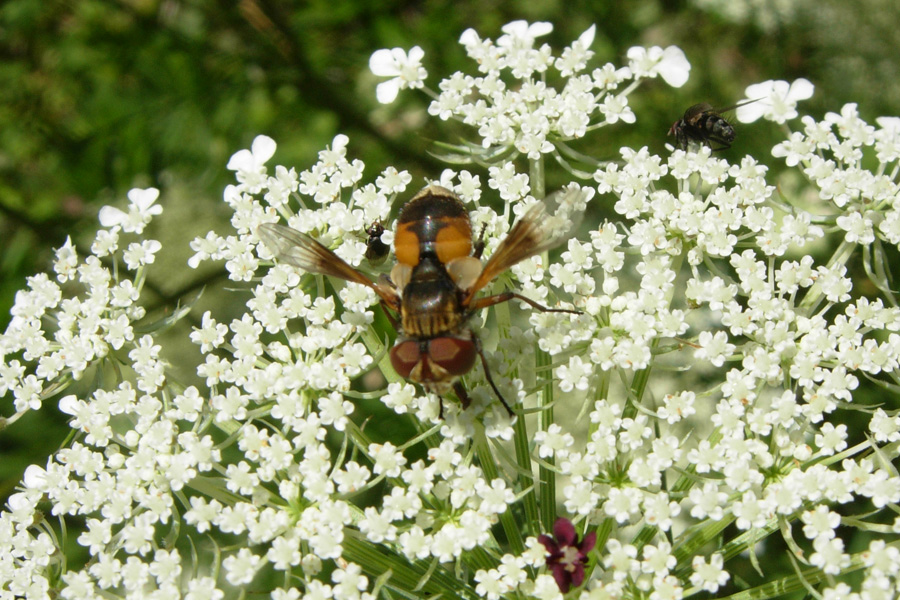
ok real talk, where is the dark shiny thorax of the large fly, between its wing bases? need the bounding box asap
[400,253,467,338]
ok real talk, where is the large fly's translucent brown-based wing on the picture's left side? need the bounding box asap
[256,223,400,308]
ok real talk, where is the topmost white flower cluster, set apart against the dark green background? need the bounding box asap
[370,21,690,160]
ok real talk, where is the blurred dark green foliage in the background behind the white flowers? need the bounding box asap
[0,0,900,576]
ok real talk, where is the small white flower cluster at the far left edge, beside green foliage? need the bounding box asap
[0,189,162,420]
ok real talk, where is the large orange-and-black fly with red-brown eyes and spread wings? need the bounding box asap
[257,185,583,417]
